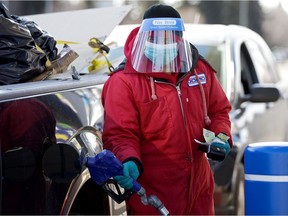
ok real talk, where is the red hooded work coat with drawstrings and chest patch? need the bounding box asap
[102,28,232,215]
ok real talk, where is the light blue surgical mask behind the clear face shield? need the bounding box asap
[144,41,177,67]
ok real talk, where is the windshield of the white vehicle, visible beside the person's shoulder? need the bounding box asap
[195,43,227,87]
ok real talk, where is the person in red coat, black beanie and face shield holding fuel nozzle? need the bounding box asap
[102,4,232,215]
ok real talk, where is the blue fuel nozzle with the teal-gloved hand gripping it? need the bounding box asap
[85,150,169,215]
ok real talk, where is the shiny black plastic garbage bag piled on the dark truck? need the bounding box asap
[0,3,57,85]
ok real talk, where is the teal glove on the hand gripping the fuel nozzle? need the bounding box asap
[113,161,139,190]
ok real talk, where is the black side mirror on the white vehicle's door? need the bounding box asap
[242,83,280,103]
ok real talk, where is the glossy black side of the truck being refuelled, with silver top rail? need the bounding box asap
[0,74,125,215]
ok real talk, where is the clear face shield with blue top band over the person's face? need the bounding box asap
[132,18,192,73]
